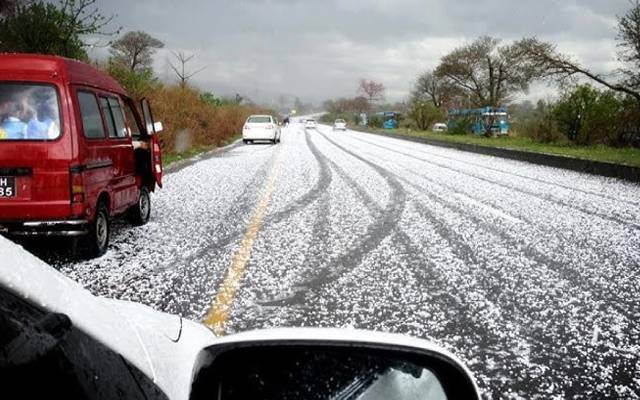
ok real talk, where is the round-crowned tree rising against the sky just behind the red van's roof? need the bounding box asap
[110,31,164,72]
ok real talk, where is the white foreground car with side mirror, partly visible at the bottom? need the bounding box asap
[0,236,480,400]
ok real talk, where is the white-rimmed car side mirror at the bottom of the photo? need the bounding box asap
[191,329,480,400]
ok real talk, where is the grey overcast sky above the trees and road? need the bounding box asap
[91,0,629,103]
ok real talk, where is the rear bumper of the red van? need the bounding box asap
[0,219,89,237]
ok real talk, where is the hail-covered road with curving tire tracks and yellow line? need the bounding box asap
[46,124,640,398]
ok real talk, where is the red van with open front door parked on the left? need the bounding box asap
[0,54,162,256]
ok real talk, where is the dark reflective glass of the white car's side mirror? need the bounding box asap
[193,346,447,400]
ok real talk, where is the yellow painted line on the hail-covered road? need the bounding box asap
[204,150,280,336]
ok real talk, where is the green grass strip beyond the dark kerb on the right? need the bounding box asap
[355,127,640,167]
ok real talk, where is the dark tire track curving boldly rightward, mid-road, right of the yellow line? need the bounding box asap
[267,132,407,306]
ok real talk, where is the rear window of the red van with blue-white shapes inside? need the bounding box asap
[0,82,61,141]
